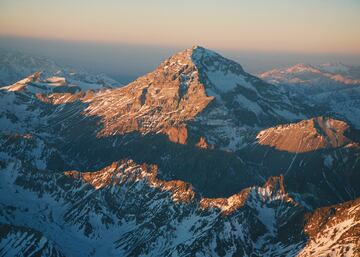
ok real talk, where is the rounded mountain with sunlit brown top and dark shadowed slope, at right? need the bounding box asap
[250,116,360,209]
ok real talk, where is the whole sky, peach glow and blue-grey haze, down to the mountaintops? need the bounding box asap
[0,0,360,80]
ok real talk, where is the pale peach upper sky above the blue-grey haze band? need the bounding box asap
[0,0,360,54]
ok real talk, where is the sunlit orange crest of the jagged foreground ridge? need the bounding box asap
[64,160,292,215]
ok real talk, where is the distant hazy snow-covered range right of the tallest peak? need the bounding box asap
[259,63,360,128]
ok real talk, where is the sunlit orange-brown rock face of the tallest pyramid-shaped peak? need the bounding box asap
[38,49,214,144]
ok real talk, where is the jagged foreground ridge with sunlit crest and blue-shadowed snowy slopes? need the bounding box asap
[1,147,305,256]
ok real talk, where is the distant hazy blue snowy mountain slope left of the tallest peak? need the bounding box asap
[0,49,121,90]
